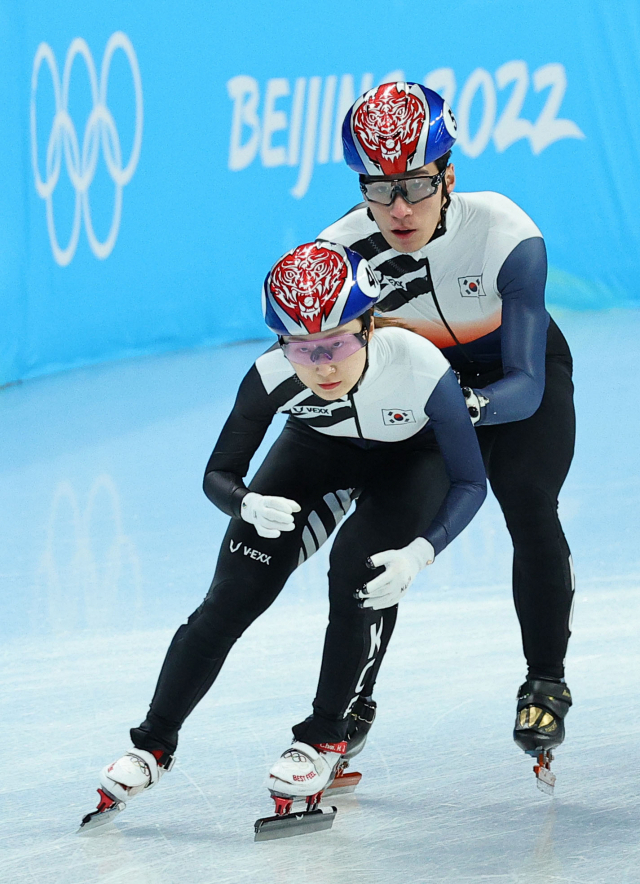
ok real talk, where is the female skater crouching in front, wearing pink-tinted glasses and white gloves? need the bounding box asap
[82,243,486,827]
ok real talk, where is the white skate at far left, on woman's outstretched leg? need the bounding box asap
[78,748,174,831]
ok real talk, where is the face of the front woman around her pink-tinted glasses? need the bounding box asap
[284,319,373,402]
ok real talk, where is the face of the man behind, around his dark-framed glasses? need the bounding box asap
[365,163,456,252]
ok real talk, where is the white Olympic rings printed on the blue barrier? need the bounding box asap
[31,31,143,267]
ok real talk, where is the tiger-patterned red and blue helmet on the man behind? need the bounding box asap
[342,83,458,176]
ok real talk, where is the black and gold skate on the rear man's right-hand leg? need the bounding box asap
[513,678,571,795]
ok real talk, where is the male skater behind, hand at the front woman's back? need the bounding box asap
[319,82,575,772]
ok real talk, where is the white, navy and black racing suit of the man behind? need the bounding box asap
[319,192,575,678]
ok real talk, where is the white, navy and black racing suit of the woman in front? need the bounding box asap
[131,328,486,753]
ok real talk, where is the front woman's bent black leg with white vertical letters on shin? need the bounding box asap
[293,450,449,743]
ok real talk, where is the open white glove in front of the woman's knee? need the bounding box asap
[355,537,436,611]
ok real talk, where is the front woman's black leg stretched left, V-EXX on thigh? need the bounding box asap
[131,426,361,753]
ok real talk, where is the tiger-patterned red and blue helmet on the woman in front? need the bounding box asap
[262,241,380,335]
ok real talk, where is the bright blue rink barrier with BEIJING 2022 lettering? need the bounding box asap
[0,0,640,385]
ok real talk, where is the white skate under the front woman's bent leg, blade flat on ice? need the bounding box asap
[255,740,347,841]
